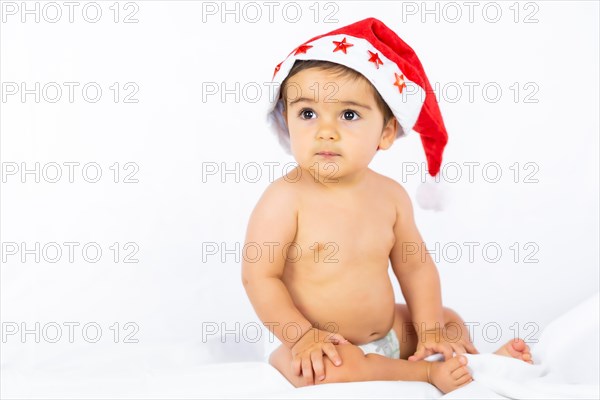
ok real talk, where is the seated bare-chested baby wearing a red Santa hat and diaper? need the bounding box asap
[242,18,532,393]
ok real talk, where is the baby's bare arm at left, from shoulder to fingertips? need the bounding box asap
[242,179,343,380]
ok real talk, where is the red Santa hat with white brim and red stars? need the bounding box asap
[268,18,448,211]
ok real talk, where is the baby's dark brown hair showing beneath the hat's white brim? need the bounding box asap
[279,60,394,126]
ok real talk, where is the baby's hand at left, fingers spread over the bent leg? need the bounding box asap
[292,328,349,385]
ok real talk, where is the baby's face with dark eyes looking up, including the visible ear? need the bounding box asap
[285,68,396,180]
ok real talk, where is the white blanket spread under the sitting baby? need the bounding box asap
[0,294,600,399]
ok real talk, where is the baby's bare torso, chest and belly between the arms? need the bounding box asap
[282,171,396,345]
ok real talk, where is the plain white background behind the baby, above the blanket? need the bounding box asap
[0,1,599,388]
